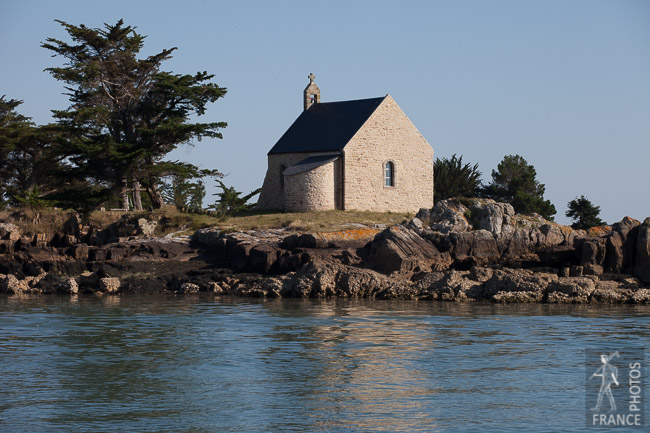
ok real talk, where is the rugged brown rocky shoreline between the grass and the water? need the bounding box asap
[0,200,650,304]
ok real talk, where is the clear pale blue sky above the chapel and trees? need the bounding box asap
[0,0,650,223]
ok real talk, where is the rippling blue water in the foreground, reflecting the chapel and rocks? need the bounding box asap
[0,296,650,432]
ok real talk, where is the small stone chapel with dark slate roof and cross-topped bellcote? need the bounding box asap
[256,74,433,212]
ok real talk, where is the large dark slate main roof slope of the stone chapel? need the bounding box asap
[268,96,386,155]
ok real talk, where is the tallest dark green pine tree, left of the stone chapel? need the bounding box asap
[42,20,226,212]
